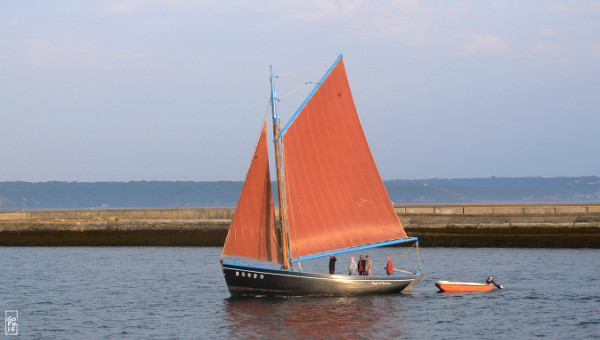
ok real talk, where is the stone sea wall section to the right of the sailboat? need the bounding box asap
[396,204,600,248]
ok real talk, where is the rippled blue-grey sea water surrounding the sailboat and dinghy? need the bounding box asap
[0,247,600,339]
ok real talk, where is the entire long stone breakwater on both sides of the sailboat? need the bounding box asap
[0,204,600,248]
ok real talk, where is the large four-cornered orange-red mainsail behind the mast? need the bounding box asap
[283,58,406,258]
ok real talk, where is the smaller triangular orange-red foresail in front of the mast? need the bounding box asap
[221,121,283,263]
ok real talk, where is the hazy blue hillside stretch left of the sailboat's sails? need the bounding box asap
[0,181,243,210]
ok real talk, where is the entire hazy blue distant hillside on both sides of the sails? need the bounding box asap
[0,176,600,210]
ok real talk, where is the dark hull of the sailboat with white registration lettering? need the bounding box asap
[222,263,423,296]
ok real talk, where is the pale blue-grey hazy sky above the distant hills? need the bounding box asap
[0,0,600,182]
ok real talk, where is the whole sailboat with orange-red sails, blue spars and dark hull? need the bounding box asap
[220,55,423,296]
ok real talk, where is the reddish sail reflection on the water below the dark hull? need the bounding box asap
[224,295,409,338]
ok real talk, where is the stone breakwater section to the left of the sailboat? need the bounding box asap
[0,208,234,246]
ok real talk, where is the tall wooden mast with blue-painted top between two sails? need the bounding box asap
[270,65,291,269]
